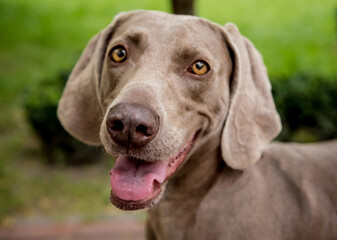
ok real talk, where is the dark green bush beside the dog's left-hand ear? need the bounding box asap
[24,73,102,164]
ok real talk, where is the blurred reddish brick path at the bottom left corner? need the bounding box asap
[0,219,145,240]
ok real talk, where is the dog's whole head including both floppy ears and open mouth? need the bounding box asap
[58,11,281,210]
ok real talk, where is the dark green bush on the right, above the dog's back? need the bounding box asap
[271,74,337,142]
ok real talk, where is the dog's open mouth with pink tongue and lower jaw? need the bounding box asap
[110,131,199,210]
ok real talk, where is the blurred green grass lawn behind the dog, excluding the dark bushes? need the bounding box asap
[0,0,337,223]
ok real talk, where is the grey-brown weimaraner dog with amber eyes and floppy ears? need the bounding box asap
[58,11,337,240]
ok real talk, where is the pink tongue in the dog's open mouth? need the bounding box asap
[110,156,169,201]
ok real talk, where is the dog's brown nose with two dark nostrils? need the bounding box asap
[106,103,159,148]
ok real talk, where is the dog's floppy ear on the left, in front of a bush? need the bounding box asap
[57,14,126,145]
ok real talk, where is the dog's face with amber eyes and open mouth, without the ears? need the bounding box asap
[100,13,231,209]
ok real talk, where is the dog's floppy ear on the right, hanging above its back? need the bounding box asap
[221,23,281,170]
